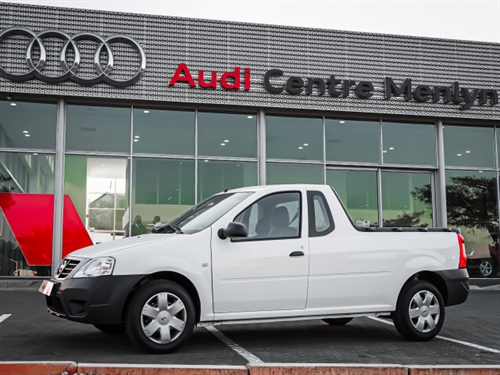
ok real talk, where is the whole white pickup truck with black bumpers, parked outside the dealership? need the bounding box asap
[40,185,469,353]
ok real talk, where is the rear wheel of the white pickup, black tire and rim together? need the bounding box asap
[392,280,445,341]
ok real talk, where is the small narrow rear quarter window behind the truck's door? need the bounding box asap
[307,191,334,237]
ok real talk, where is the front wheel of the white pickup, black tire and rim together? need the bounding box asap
[125,280,195,354]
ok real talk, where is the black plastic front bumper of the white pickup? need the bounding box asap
[46,275,143,324]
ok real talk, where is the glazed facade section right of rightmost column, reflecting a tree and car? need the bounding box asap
[443,124,500,277]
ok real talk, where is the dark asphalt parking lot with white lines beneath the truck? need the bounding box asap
[0,288,500,366]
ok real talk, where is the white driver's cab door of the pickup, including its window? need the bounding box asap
[212,191,309,315]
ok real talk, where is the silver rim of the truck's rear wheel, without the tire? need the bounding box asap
[408,290,441,333]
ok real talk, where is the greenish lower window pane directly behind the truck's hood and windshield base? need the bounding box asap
[132,158,195,234]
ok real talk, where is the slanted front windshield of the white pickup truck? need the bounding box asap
[166,192,253,233]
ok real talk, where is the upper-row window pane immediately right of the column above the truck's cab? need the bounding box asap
[266,116,323,161]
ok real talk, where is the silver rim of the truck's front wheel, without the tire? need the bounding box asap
[141,292,187,344]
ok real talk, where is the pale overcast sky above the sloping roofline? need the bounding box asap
[0,0,500,43]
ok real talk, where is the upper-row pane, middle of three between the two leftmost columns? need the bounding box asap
[133,109,194,155]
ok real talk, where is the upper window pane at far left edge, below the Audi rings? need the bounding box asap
[0,101,57,150]
